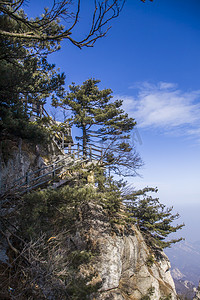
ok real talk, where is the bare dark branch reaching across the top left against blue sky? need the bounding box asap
[0,0,125,48]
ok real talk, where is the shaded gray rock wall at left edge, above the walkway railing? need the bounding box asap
[0,138,63,193]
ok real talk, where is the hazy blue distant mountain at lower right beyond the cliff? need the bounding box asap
[165,241,200,287]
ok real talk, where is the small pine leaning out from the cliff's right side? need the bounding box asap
[124,188,184,249]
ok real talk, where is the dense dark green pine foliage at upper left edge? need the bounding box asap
[0,50,64,141]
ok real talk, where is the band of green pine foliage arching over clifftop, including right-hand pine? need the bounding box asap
[22,168,184,251]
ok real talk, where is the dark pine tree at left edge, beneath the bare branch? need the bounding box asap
[0,15,65,140]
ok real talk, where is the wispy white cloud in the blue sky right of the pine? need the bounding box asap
[118,82,200,136]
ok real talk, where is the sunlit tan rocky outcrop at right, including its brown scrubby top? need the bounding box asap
[71,203,177,300]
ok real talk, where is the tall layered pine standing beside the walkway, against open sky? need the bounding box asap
[61,79,141,175]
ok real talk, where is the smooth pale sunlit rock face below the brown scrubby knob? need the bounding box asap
[96,231,176,299]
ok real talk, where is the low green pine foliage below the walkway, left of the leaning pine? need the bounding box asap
[21,176,122,239]
